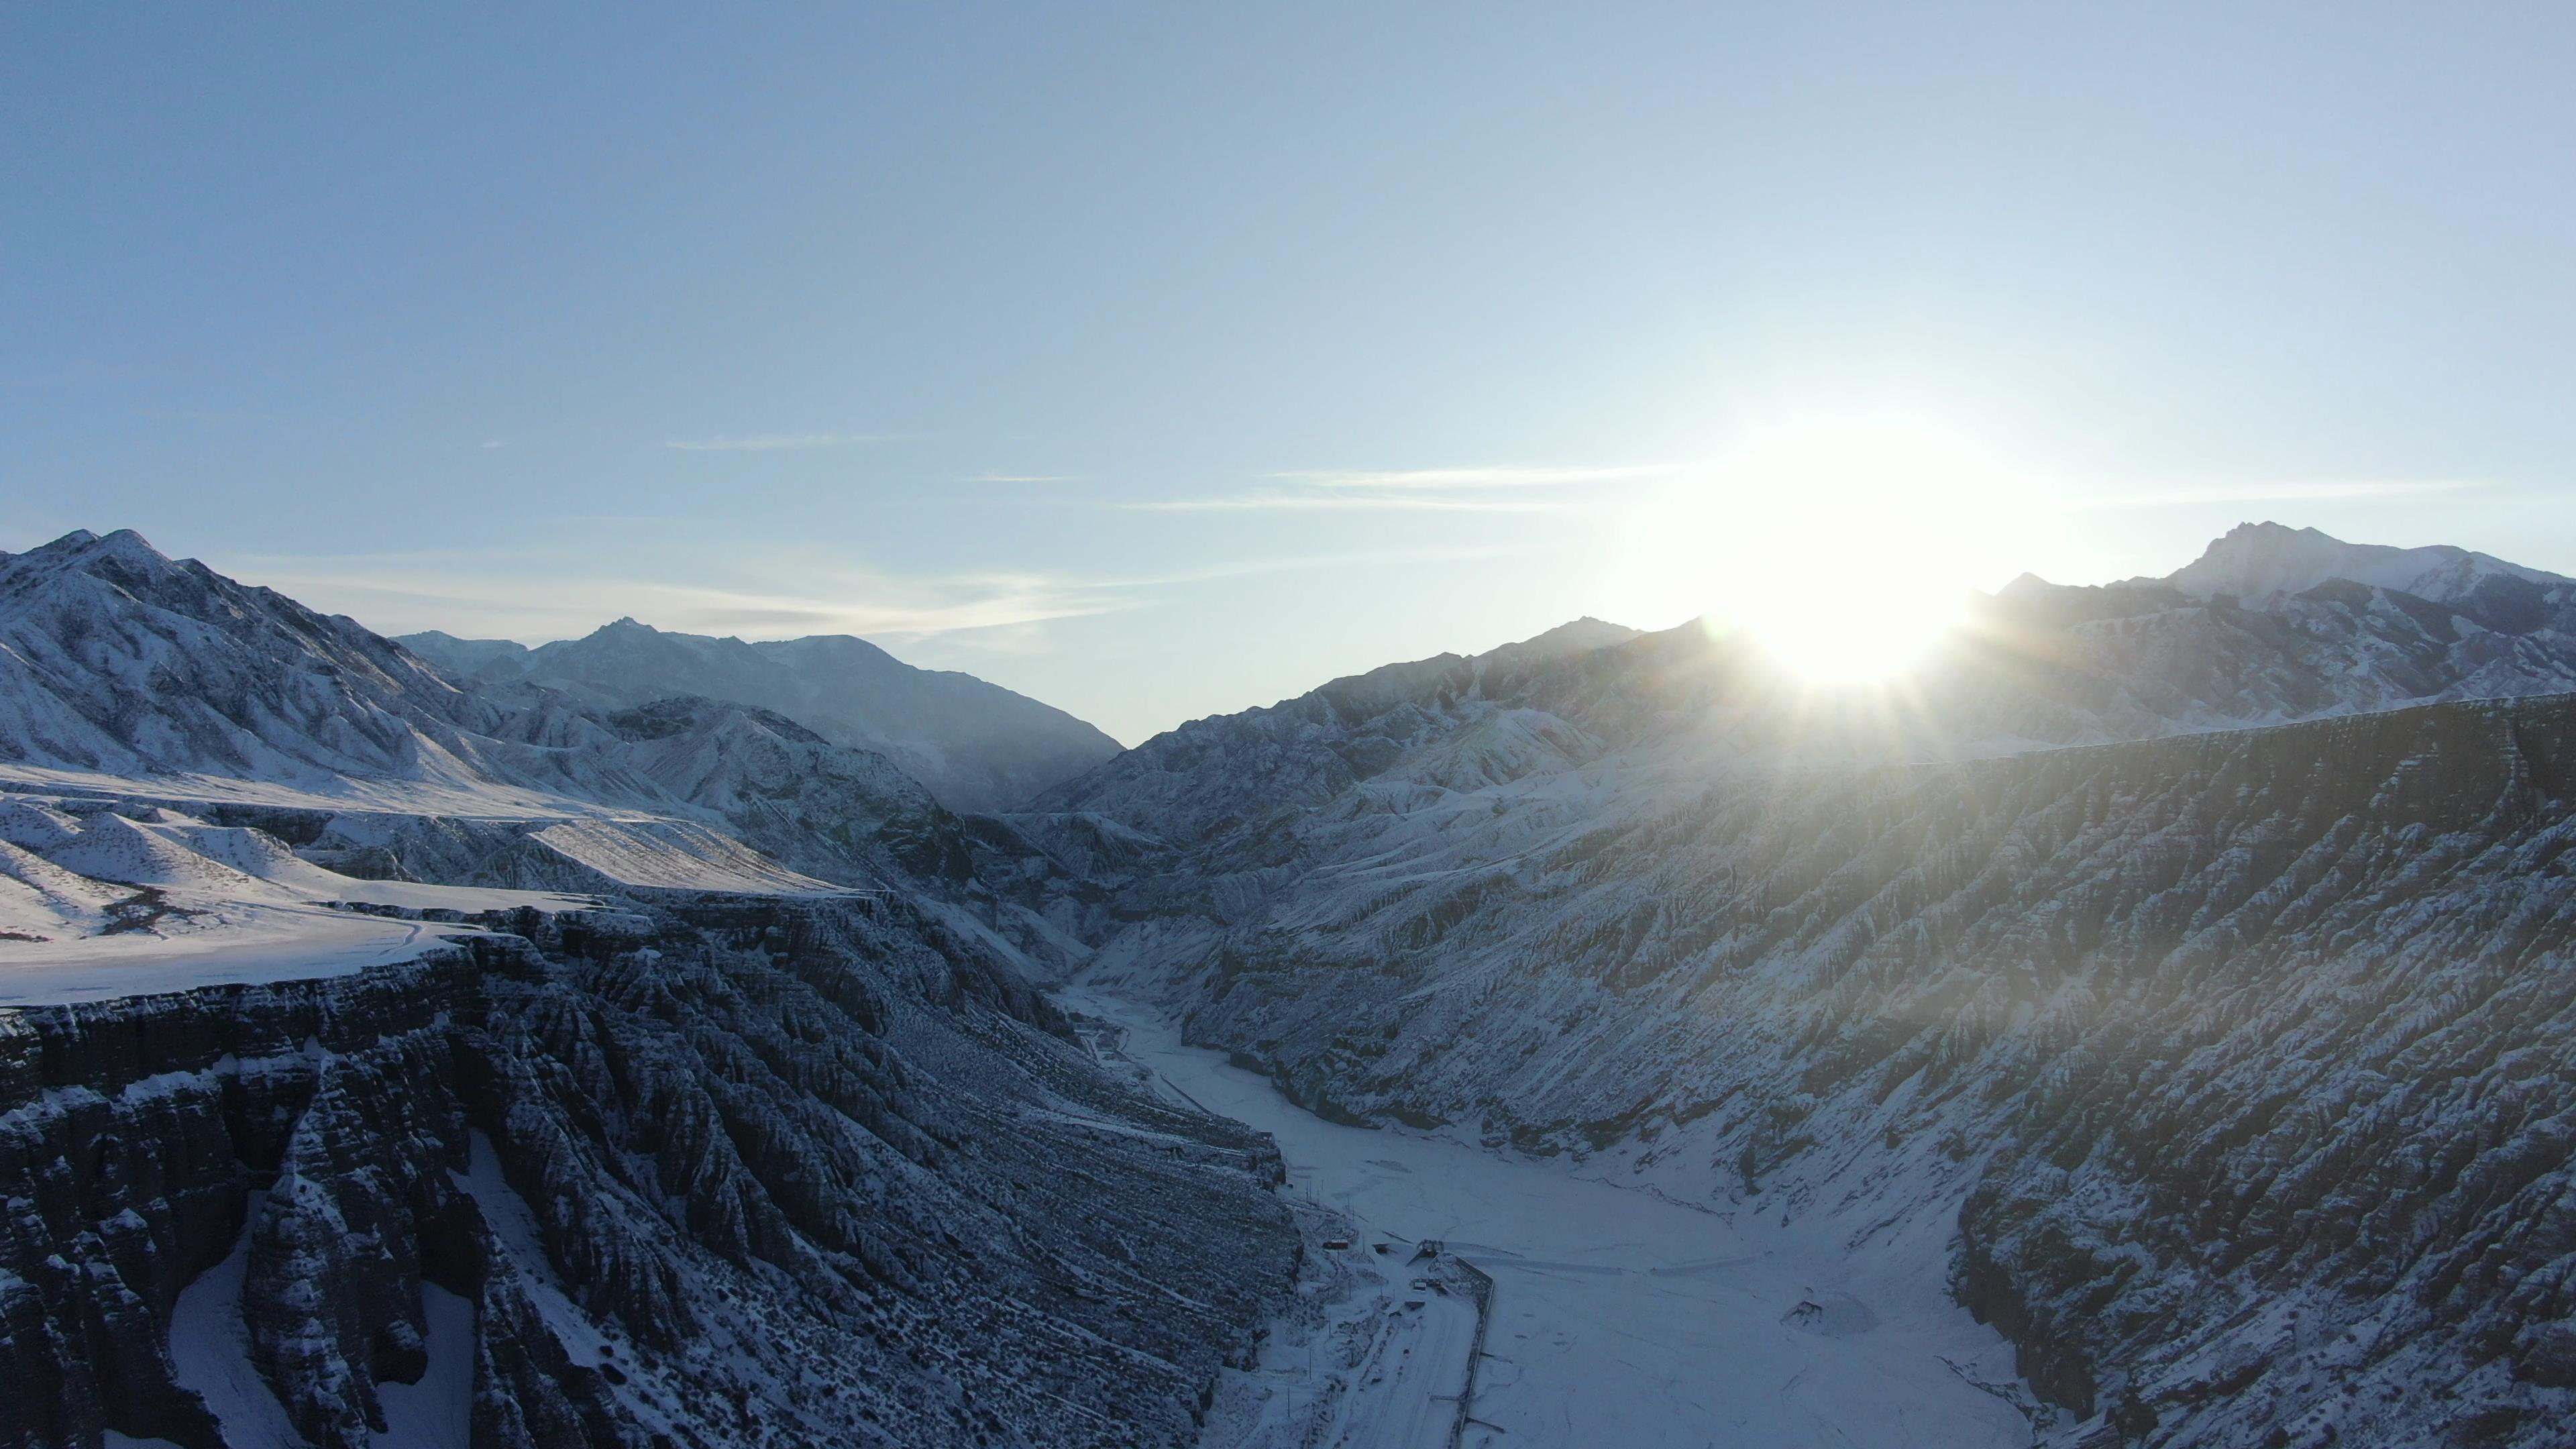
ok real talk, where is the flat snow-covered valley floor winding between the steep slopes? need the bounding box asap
[1061,987,2030,1449]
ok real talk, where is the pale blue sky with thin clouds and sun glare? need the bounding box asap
[0,3,2576,743]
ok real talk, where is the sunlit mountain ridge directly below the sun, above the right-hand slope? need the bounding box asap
[1036,526,2576,841]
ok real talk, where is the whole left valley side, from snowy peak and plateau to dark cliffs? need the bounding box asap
[0,534,1298,1449]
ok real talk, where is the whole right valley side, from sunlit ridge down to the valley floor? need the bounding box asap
[976,529,2576,1449]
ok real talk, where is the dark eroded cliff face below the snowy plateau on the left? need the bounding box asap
[0,898,1296,1449]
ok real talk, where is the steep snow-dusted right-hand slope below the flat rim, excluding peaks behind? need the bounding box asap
[1061,699,2576,1446]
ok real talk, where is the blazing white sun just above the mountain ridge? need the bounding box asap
[1644,415,2030,684]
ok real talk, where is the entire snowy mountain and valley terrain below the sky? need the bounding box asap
[0,523,2576,1449]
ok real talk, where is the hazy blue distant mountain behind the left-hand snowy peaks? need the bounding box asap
[399,619,1118,810]
